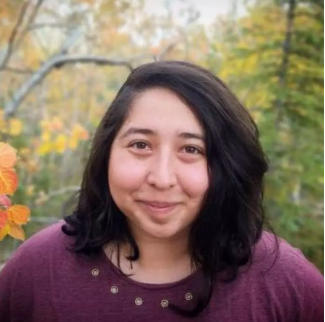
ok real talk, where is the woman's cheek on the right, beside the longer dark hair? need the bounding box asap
[179,165,209,200]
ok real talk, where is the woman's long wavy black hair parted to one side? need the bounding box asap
[62,61,268,317]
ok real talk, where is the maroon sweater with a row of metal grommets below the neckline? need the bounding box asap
[0,222,324,322]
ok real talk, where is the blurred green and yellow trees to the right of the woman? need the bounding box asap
[206,1,324,270]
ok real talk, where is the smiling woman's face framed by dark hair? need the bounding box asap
[108,88,208,238]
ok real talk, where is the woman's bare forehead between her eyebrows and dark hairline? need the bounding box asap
[124,88,204,134]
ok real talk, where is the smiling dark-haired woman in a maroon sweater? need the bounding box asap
[0,61,323,322]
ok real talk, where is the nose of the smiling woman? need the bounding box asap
[147,152,177,190]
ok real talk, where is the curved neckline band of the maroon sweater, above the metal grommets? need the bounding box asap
[100,249,201,290]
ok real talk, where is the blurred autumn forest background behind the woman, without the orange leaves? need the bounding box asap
[0,0,324,271]
